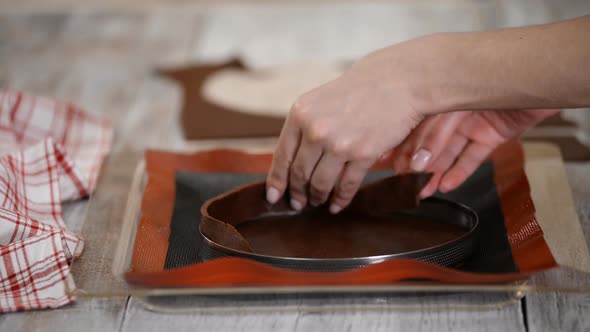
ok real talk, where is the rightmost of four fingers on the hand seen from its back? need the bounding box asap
[330,161,372,214]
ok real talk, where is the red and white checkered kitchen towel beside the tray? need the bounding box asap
[0,91,112,312]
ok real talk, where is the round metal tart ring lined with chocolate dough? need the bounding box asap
[199,174,478,272]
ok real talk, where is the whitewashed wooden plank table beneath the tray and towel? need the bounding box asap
[0,0,590,331]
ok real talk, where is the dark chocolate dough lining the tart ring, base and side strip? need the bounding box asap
[200,173,440,258]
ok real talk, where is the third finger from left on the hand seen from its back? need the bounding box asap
[309,153,346,206]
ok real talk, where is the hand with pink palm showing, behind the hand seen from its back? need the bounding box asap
[393,109,559,197]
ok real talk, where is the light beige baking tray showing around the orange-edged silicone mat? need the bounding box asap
[73,143,590,312]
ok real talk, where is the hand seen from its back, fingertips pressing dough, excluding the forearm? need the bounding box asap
[267,53,421,213]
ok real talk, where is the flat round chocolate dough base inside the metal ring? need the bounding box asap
[236,210,467,258]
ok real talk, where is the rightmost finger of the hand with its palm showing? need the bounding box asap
[439,142,496,192]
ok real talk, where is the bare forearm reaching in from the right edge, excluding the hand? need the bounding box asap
[380,16,590,114]
